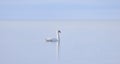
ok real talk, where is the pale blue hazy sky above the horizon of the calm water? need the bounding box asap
[0,0,120,20]
